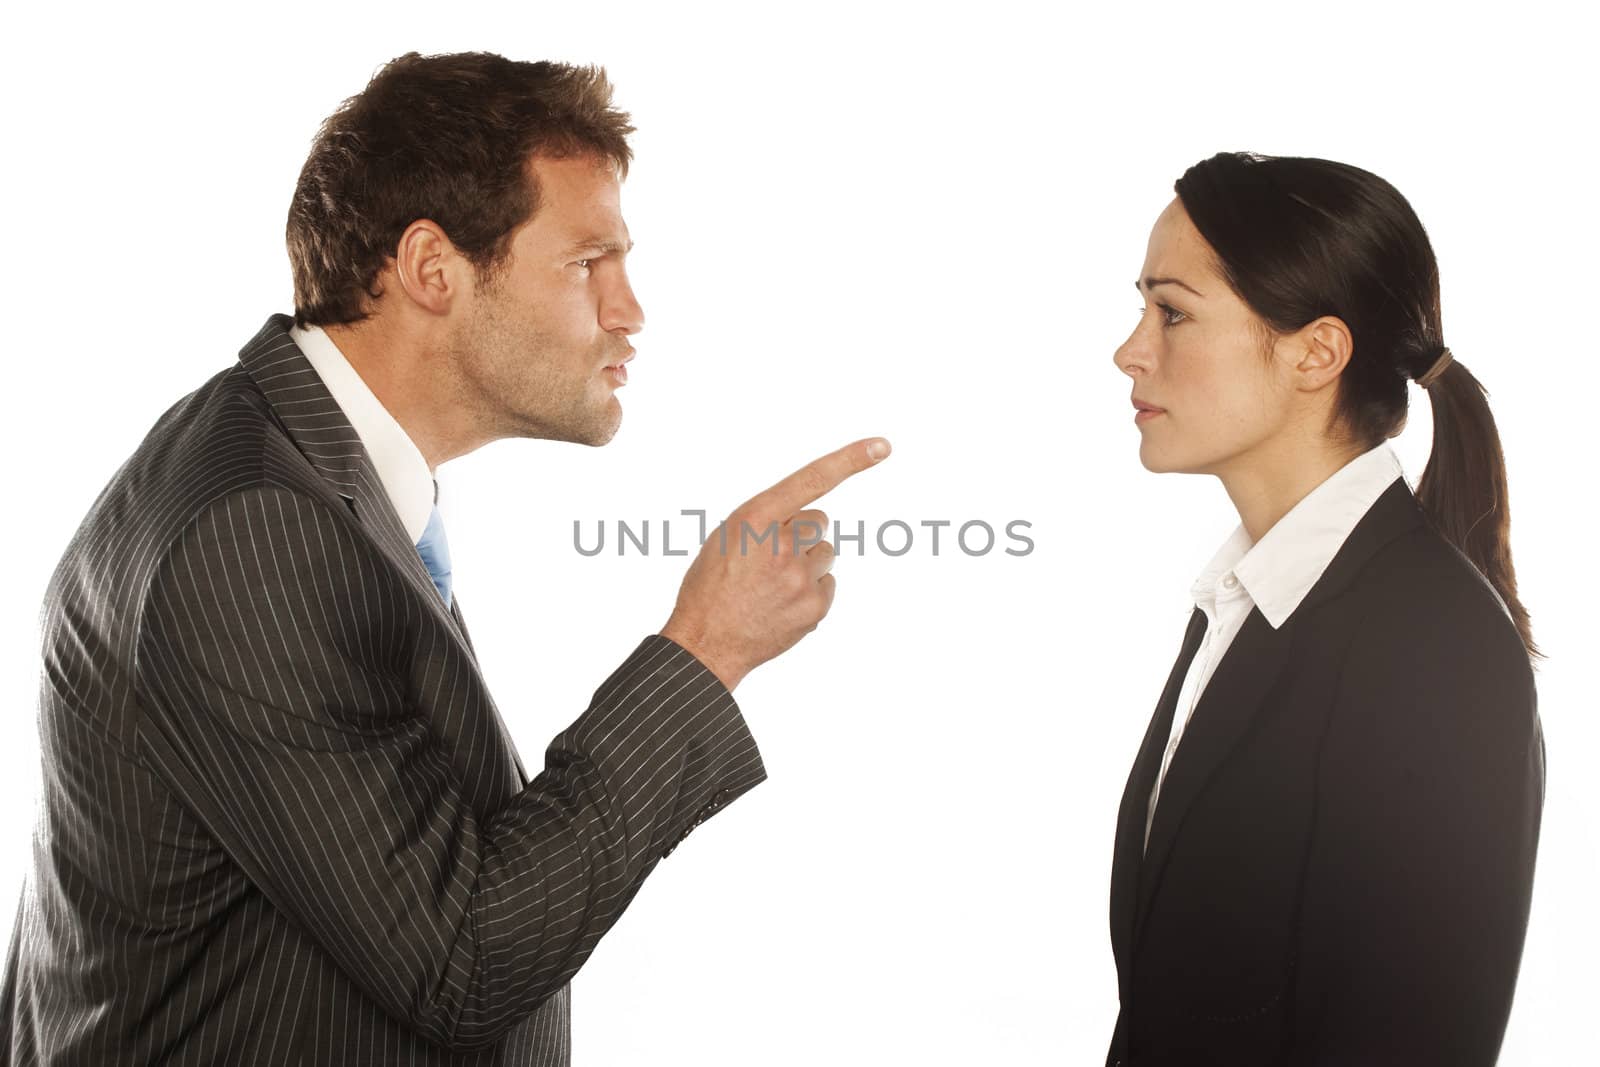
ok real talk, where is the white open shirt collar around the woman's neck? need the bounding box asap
[1189,442,1402,629]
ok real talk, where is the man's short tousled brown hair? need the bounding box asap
[286,51,634,328]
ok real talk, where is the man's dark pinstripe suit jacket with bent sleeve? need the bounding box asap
[0,315,765,1067]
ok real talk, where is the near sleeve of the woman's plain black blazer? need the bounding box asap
[1290,584,1544,1067]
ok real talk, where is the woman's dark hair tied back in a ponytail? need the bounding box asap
[1176,152,1544,659]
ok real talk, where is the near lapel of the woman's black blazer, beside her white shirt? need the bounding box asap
[1118,477,1426,945]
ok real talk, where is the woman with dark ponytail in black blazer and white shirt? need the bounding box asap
[1107,154,1544,1067]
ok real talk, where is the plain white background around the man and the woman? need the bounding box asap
[0,2,1600,1067]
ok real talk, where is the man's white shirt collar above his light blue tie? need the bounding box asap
[290,326,438,542]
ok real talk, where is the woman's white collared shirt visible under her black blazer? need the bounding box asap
[1144,442,1402,846]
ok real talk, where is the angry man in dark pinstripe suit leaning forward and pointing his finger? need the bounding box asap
[0,47,886,1065]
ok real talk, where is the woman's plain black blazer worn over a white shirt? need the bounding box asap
[1107,478,1544,1067]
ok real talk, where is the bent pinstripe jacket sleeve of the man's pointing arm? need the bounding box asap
[138,488,765,1048]
